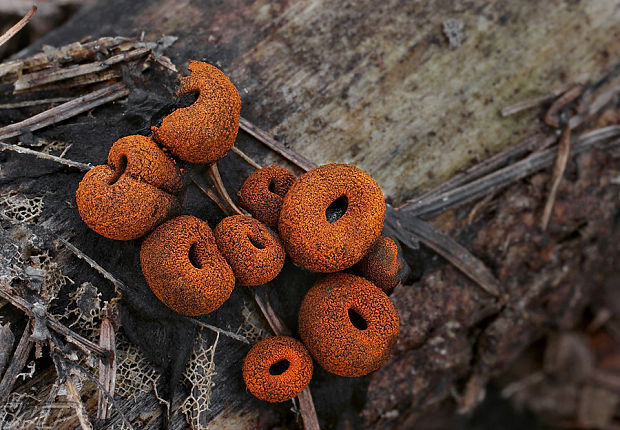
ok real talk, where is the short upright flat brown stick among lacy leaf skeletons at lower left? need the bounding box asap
[97,318,116,420]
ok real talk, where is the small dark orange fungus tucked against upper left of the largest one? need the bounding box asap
[239,166,295,230]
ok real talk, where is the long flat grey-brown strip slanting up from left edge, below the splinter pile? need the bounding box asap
[0,83,129,139]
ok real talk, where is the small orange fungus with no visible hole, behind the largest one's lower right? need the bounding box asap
[357,236,405,291]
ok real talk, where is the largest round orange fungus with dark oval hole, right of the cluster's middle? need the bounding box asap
[278,164,385,273]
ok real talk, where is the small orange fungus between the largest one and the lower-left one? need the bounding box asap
[214,215,286,286]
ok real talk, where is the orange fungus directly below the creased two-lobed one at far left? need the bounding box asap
[140,215,235,316]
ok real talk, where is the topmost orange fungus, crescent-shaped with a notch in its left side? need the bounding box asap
[151,60,241,164]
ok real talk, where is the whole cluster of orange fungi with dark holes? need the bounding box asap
[76,61,401,402]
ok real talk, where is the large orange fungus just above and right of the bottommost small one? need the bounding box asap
[299,273,399,377]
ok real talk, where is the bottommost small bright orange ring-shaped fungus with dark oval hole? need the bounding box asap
[243,336,313,403]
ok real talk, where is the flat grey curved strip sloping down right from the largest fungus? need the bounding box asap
[385,206,500,297]
